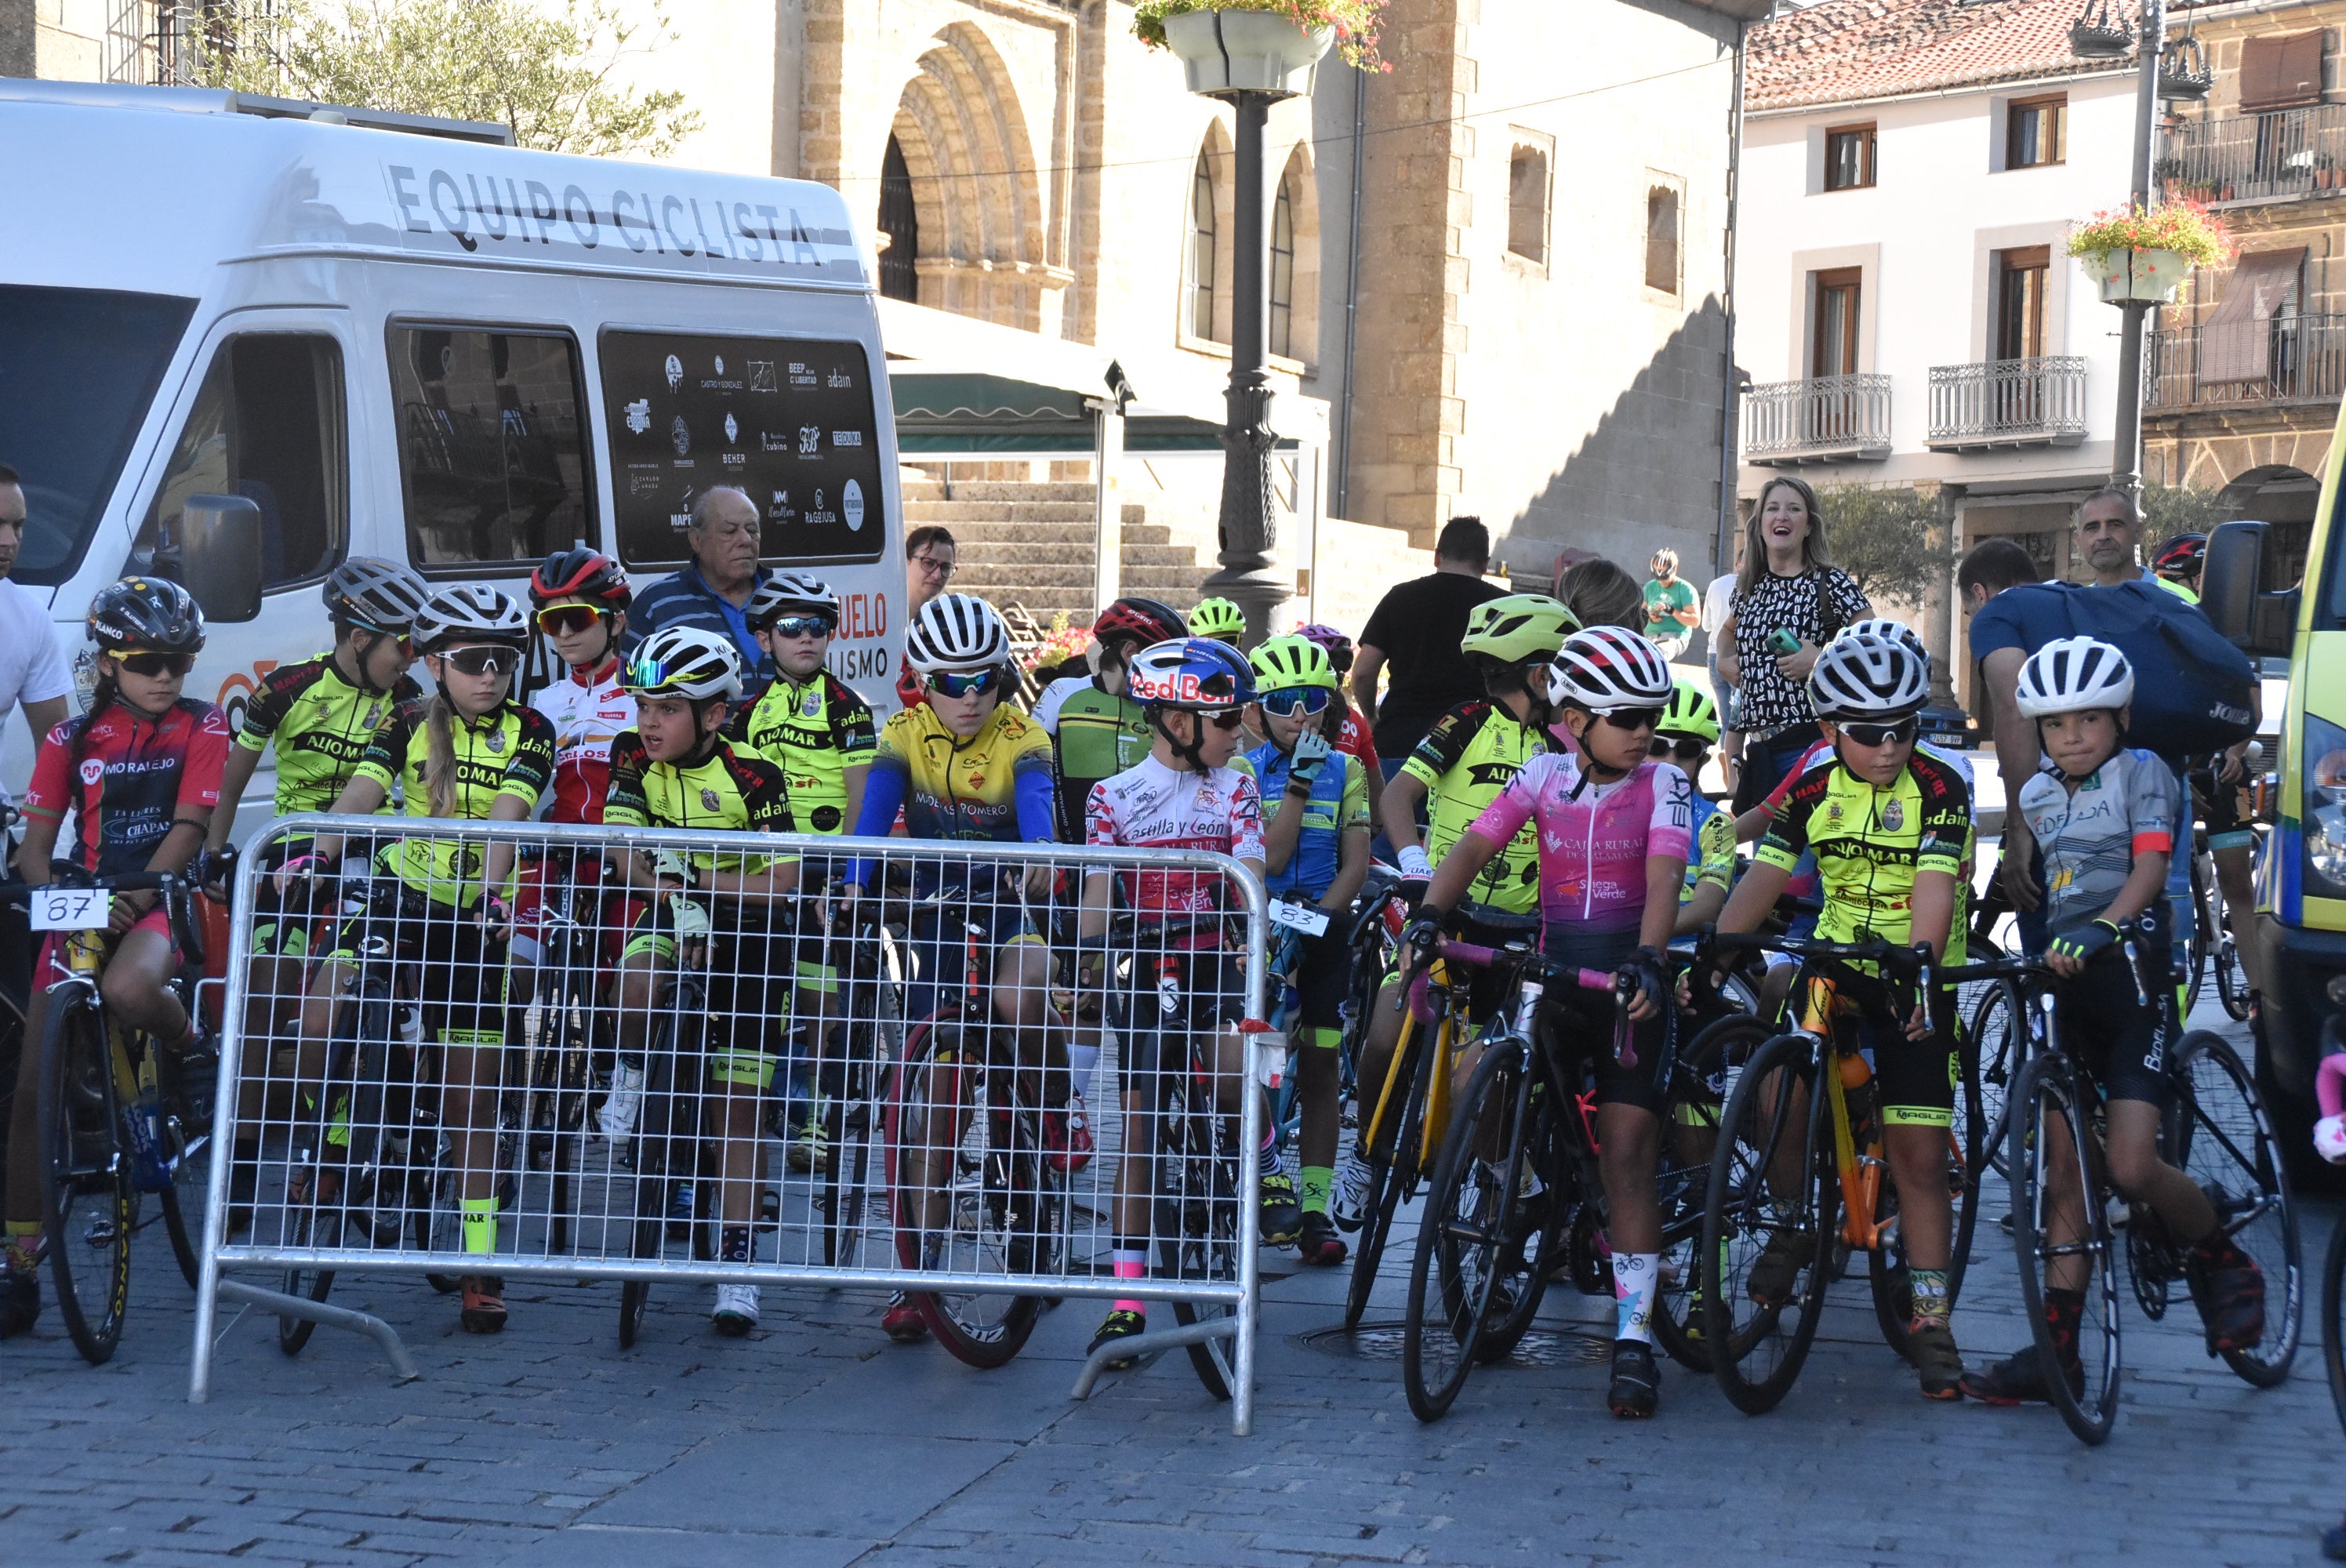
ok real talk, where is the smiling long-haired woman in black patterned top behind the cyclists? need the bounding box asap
[1720,474,1875,810]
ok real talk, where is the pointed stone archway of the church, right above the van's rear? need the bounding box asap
[889,21,1067,331]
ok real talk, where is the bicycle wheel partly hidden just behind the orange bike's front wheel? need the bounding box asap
[1651,1014,1769,1375]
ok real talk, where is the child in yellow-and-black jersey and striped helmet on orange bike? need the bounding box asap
[1720,633,1970,1399]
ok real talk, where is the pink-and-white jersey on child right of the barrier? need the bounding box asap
[1466,751,1694,939]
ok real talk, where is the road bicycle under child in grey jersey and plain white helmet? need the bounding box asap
[1947,930,2301,1443]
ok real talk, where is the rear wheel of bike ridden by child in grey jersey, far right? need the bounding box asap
[2168,1030,2304,1387]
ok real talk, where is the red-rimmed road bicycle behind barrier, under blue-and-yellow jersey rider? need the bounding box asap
[884,899,1067,1369]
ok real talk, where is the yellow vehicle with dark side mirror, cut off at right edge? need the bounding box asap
[2200,504,2346,1174]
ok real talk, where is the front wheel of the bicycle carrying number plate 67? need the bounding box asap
[38,985,139,1367]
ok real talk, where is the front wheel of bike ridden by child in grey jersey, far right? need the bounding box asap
[2006,1054,2121,1443]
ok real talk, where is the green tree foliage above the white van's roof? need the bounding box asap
[197,0,702,158]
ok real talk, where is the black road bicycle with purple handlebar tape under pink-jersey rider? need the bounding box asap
[1400,942,1717,1422]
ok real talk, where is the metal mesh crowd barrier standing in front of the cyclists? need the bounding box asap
[190,815,1281,1434]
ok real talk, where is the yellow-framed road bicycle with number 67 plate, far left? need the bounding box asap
[12,862,216,1367]
